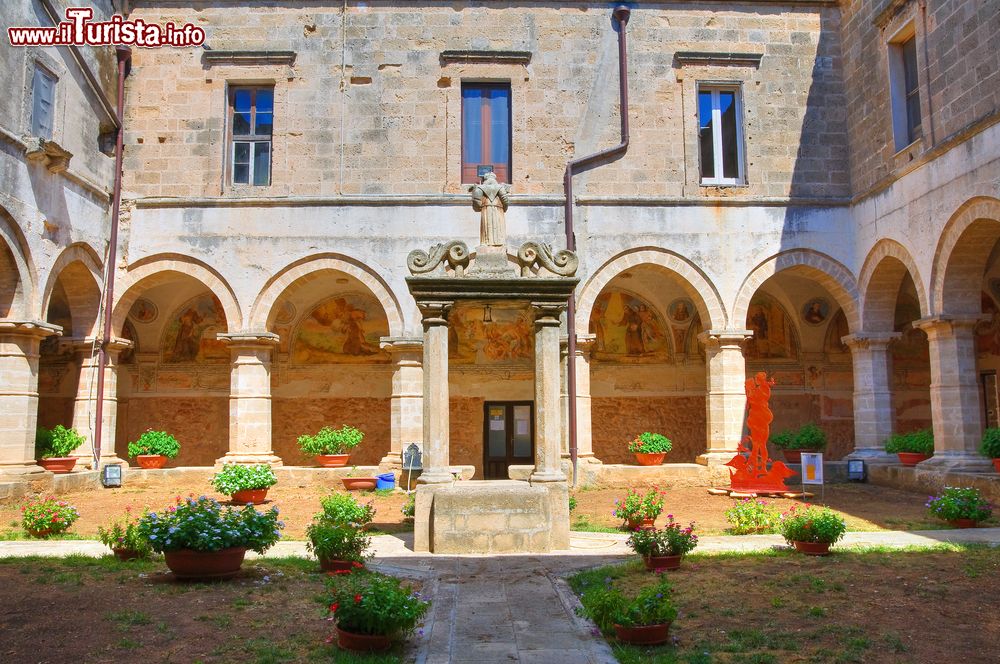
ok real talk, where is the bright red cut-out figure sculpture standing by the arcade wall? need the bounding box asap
[726,371,795,493]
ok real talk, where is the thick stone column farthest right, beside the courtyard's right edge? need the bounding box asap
[913,316,993,471]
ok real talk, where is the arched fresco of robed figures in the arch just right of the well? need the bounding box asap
[590,290,671,363]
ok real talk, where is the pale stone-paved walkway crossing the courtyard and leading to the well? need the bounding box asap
[0,528,1000,664]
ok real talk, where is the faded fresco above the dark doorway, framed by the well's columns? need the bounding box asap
[448,303,535,364]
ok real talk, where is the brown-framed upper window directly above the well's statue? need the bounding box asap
[462,83,511,183]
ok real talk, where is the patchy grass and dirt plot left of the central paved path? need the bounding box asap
[0,556,410,664]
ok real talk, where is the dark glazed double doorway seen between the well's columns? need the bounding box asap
[483,401,535,480]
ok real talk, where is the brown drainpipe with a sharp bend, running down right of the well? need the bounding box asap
[563,5,632,487]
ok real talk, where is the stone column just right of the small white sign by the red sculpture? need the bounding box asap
[841,332,900,462]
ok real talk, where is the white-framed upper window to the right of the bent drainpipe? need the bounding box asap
[698,86,745,185]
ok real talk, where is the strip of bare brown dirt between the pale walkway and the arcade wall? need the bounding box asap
[0,484,960,540]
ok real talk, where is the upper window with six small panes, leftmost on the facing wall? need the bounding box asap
[229,88,274,186]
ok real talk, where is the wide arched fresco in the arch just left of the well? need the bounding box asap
[290,293,389,364]
